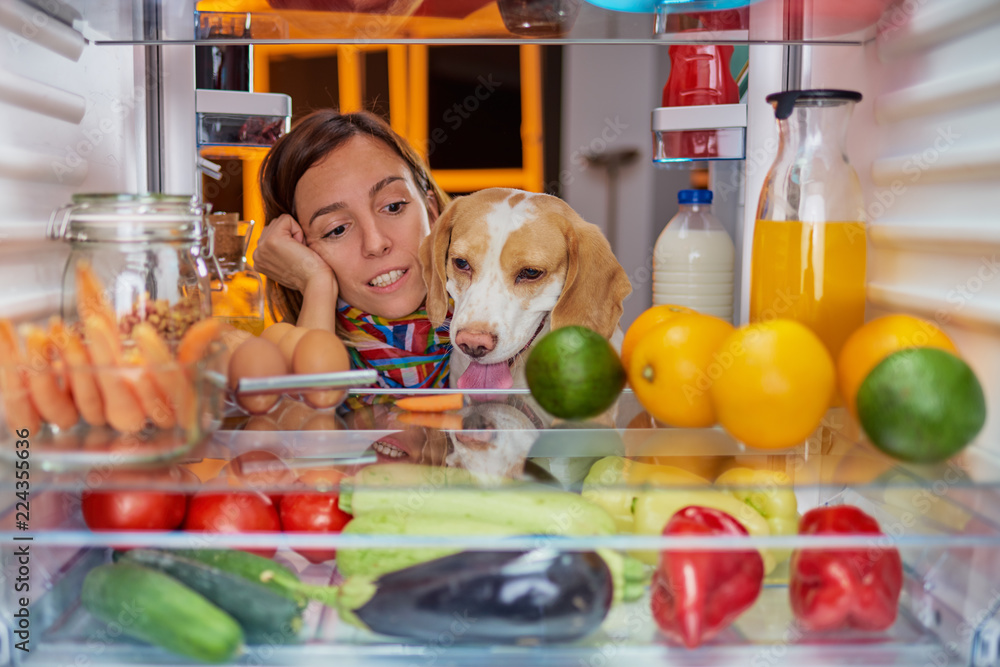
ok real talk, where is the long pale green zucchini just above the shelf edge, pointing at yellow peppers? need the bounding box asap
[342,484,615,535]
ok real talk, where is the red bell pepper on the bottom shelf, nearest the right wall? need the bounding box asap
[788,505,903,630]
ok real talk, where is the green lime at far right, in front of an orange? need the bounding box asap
[857,347,986,463]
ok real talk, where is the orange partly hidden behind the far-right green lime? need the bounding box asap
[837,314,958,419]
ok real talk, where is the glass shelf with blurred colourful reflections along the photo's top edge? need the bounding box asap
[54,0,892,48]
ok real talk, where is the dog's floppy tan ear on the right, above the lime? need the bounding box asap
[552,202,632,338]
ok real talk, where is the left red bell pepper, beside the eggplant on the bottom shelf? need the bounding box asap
[652,505,764,648]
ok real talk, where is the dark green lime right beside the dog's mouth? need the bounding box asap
[524,326,625,419]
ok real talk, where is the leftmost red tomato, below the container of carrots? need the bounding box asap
[80,469,187,531]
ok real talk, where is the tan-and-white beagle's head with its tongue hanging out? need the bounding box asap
[420,188,632,389]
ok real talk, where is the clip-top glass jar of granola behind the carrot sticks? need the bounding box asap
[48,194,212,346]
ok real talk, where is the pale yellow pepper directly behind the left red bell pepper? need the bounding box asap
[630,489,777,574]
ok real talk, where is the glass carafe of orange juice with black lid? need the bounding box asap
[750,90,867,359]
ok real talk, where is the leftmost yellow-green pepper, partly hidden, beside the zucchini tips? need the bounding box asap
[581,456,709,533]
